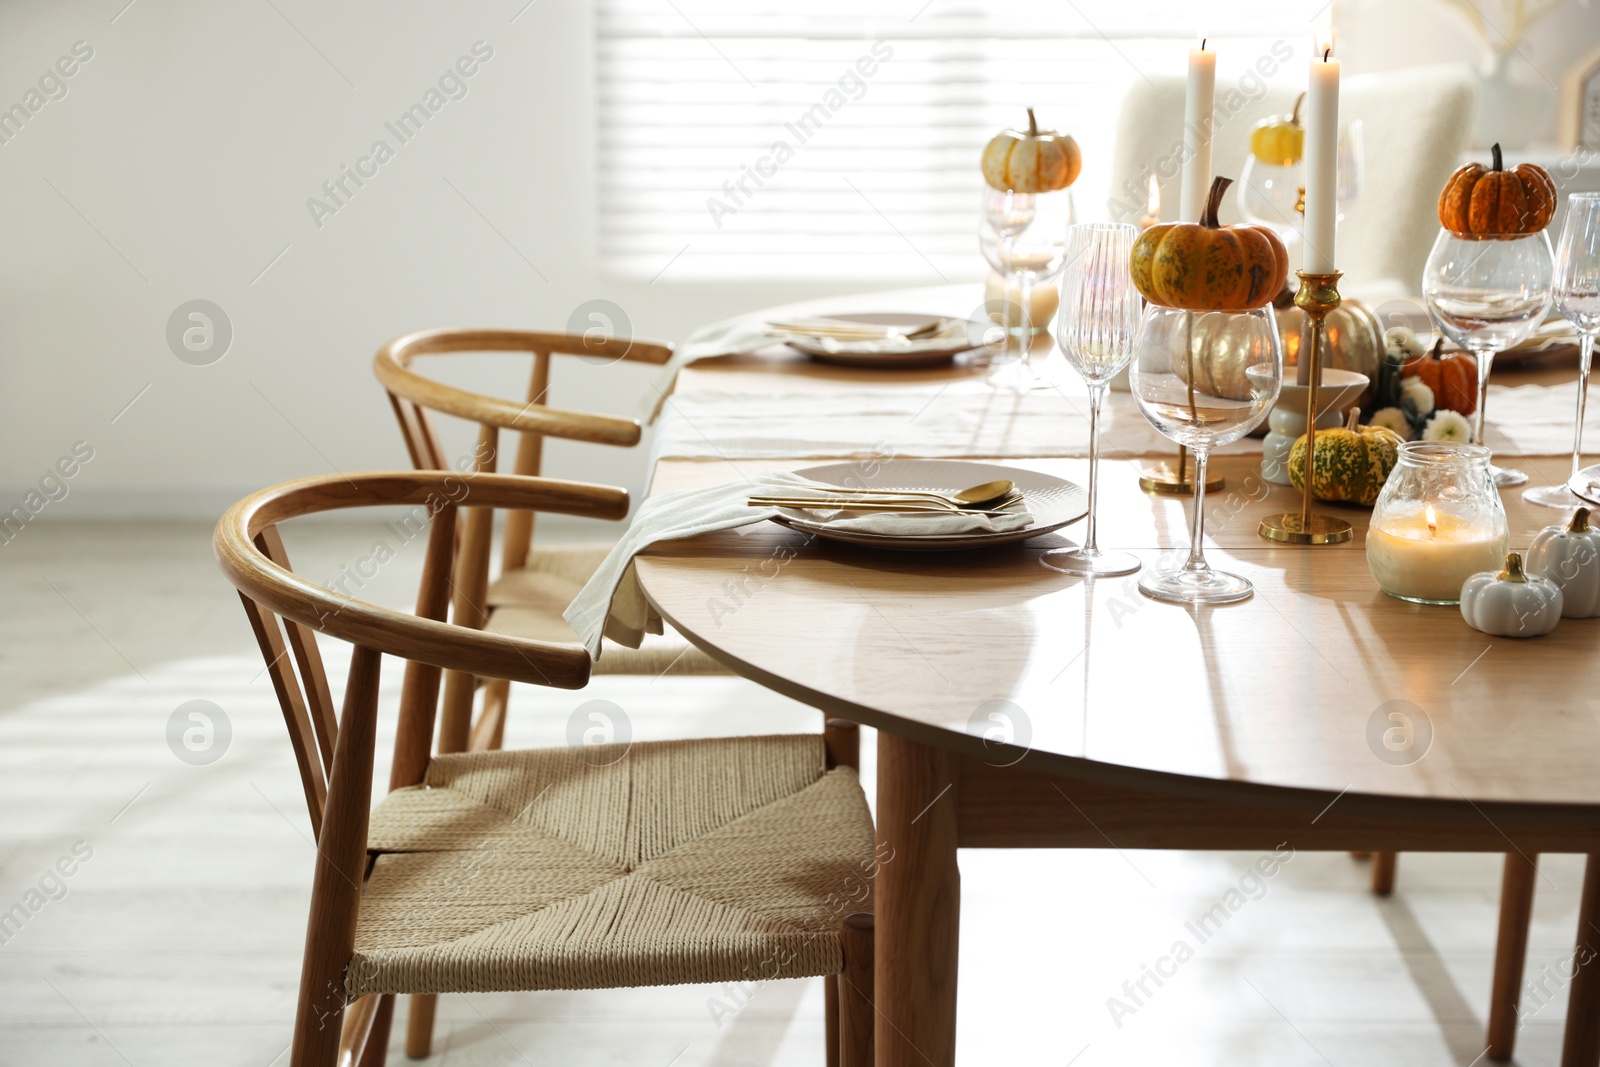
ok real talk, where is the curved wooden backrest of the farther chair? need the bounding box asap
[373,330,672,625]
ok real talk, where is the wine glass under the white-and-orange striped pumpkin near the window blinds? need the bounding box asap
[978,187,1074,392]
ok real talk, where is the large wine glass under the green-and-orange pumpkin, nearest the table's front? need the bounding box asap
[1128,304,1283,603]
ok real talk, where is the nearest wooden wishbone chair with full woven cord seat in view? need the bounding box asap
[214,470,875,1067]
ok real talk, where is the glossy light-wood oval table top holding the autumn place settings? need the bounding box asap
[638,283,1600,805]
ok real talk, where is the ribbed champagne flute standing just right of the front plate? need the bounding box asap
[1040,222,1139,576]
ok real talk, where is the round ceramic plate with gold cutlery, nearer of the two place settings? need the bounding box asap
[773,459,1090,552]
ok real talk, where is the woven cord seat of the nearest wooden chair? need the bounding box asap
[346,734,874,997]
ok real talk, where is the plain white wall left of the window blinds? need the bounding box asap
[0,0,851,518]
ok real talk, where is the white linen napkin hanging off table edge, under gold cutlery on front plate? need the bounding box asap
[562,470,1034,657]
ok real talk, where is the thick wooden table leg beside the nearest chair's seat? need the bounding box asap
[874,733,962,1067]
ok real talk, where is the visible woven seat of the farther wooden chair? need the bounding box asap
[486,545,728,675]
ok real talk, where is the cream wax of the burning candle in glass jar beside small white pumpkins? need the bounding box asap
[1366,504,1507,603]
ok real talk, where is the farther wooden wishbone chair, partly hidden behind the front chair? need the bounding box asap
[373,330,726,752]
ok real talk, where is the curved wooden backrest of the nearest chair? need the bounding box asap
[213,470,627,840]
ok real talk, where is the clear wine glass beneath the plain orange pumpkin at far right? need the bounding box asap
[1422,229,1555,488]
